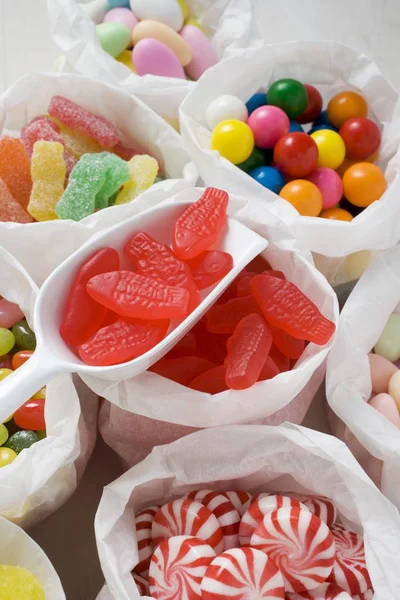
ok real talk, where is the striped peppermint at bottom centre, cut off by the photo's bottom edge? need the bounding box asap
[201,548,285,600]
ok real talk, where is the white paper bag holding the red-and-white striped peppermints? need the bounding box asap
[95,424,400,600]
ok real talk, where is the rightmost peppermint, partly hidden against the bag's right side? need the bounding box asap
[329,524,372,596]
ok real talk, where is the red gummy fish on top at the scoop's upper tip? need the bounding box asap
[172,188,229,260]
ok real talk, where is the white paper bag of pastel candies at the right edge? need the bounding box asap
[326,246,400,508]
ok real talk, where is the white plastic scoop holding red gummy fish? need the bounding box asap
[0,190,268,423]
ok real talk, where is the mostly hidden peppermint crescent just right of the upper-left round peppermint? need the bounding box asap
[187,490,240,550]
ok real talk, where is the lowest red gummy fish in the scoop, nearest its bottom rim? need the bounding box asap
[79,319,169,367]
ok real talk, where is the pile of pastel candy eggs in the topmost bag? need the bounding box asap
[96,0,218,80]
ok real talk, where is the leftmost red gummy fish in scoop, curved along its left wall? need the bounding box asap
[60,248,119,346]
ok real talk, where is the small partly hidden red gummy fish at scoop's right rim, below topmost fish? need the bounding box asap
[188,250,233,290]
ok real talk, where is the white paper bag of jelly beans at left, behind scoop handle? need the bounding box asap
[0,247,98,528]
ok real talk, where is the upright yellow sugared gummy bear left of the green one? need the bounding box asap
[27,140,67,221]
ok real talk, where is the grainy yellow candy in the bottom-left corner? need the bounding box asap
[0,565,46,600]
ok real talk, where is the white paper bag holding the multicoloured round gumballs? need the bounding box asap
[180,42,400,282]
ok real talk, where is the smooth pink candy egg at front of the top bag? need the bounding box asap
[132,39,185,79]
